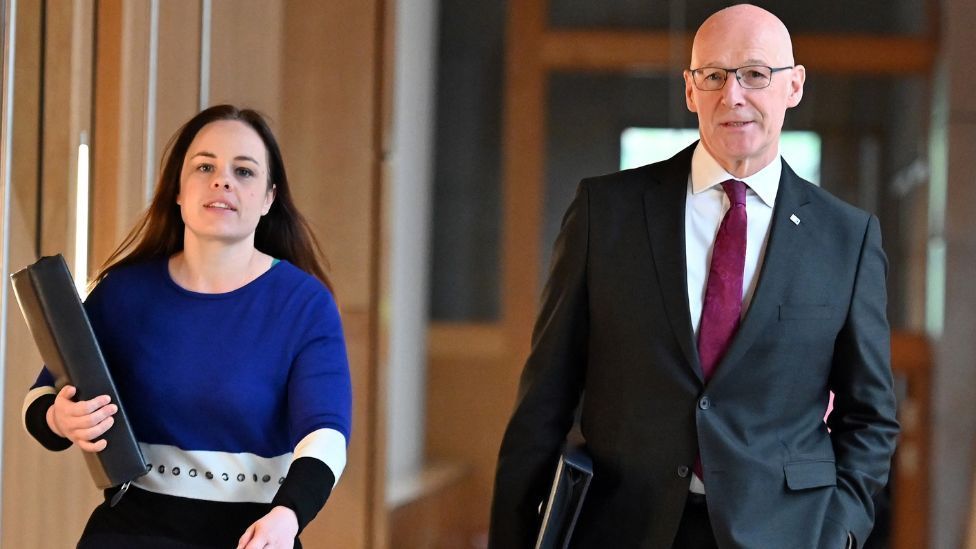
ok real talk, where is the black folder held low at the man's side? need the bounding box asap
[535,443,593,549]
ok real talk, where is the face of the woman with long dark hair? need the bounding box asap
[176,120,275,248]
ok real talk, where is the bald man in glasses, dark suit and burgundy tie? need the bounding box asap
[489,5,898,549]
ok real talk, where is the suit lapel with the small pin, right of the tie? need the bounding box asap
[710,161,814,383]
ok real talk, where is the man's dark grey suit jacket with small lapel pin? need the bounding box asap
[489,145,898,549]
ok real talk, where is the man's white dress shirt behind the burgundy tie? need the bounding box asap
[685,142,783,494]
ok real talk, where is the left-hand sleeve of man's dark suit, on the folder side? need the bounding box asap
[488,181,589,549]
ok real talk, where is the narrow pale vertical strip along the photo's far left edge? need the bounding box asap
[0,0,17,530]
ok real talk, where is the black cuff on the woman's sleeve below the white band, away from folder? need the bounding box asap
[271,457,335,533]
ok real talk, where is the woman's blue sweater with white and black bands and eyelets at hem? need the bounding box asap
[24,259,352,528]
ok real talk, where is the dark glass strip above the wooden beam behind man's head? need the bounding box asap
[549,0,927,34]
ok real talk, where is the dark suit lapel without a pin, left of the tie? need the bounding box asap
[644,143,702,379]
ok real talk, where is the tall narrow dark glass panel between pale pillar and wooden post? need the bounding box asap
[430,2,505,322]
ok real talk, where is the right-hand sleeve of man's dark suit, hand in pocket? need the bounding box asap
[825,216,898,546]
